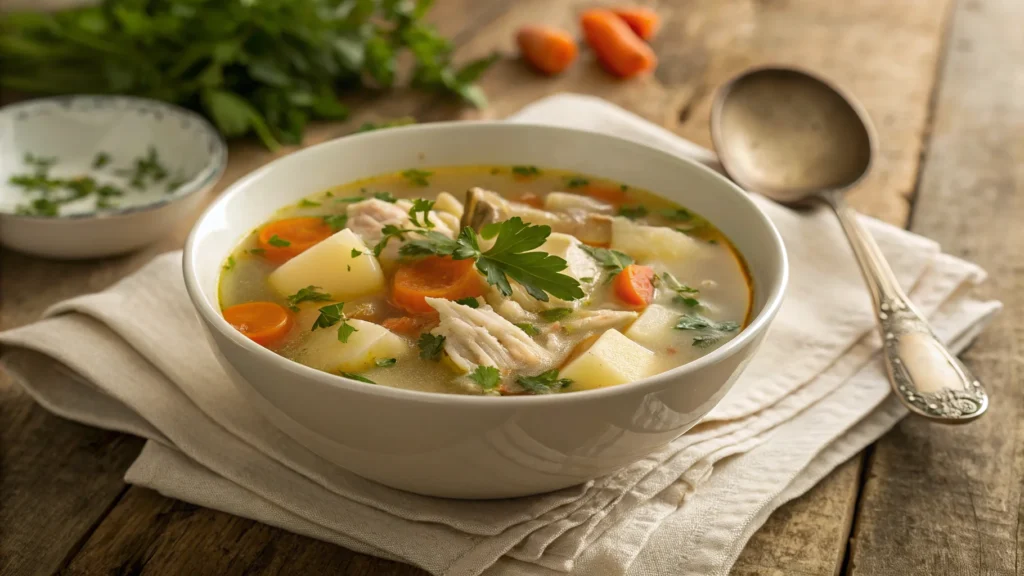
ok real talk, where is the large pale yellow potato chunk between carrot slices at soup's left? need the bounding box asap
[267,229,384,300]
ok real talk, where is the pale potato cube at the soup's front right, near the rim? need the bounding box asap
[558,329,654,390]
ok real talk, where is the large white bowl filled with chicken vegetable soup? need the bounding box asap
[184,122,787,498]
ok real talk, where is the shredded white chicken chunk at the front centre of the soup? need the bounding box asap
[427,298,554,372]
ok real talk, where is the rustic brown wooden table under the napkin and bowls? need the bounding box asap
[0,0,1024,575]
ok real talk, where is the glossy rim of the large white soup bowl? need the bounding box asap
[182,121,790,409]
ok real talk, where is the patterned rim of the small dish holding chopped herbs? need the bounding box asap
[0,94,227,222]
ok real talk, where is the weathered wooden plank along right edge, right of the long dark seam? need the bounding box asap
[851,0,1024,576]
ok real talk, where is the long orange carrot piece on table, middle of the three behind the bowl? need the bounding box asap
[580,9,657,78]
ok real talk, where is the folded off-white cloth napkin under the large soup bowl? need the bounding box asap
[0,94,1000,575]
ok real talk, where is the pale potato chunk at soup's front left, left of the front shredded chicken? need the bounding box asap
[295,320,410,372]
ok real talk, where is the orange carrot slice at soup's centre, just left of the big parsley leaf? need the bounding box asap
[391,256,483,314]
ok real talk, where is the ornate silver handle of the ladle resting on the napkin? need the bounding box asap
[822,192,988,423]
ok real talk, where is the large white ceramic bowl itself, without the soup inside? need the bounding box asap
[184,122,787,498]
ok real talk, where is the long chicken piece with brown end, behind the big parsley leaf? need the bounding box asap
[462,188,611,245]
